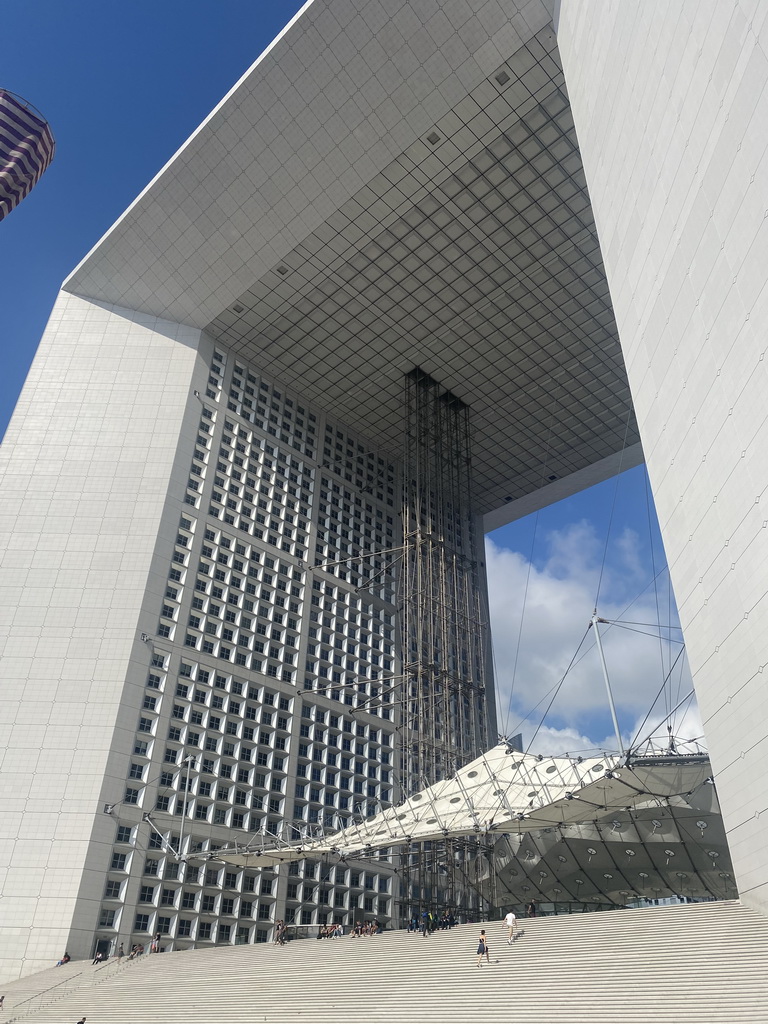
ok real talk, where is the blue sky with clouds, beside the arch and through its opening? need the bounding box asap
[0,0,700,753]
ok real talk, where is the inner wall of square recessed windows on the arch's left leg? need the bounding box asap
[105,351,400,947]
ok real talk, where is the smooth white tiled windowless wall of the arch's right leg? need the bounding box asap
[556,0,768,912]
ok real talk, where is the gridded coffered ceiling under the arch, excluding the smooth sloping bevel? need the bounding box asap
[207,32,638,513]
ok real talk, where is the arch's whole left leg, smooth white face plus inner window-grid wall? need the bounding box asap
[0,295,415,978]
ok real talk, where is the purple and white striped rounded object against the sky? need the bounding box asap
[0,89,56,220]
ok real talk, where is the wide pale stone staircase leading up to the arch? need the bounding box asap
[3,902,768,1024]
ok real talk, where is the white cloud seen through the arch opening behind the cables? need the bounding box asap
[486,521,701,753]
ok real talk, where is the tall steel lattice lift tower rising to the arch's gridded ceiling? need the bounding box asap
[399,369,496,910]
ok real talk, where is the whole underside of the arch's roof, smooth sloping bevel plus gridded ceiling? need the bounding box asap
[65,9,642,525]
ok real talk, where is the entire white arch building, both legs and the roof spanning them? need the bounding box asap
[0,0,768,978]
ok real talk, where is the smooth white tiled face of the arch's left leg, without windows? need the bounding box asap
[0,294,207,977]
